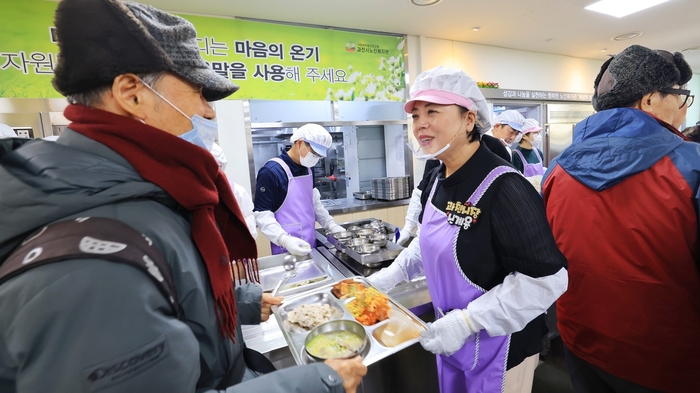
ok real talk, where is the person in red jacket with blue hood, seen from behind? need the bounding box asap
[542,45,700,393]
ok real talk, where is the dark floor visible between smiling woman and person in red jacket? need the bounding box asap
[532,337,574,393]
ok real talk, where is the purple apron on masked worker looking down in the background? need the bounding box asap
[270,157,316,255]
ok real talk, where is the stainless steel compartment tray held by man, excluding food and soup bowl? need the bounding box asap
[272,277,427,366]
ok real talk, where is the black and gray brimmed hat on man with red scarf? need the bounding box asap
[53,0,238,101]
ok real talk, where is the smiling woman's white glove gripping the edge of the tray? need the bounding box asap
[420,309,476,356]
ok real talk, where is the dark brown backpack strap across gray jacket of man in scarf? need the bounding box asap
[0,217,183,319]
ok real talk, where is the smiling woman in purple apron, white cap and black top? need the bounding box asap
[369,67,567,393]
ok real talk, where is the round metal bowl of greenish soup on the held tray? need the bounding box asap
[304,319,367,361]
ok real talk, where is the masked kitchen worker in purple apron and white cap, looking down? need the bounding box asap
[254,124,345,256]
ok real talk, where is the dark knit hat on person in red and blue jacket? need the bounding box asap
[591,45,693,111]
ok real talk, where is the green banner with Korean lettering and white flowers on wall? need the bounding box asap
[0,0,405,101]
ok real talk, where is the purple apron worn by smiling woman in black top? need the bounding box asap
[419,166,518,393]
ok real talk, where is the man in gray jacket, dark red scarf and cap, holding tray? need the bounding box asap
[0,0,367,393]
